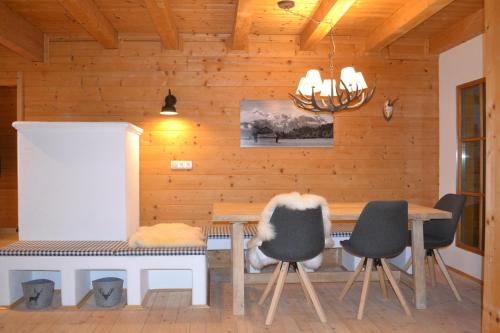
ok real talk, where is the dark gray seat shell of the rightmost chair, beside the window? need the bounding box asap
[424,193,466,246]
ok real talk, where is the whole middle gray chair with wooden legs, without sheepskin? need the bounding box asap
[339,201,411,319]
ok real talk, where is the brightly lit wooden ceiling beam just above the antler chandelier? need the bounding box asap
[300,0,356,50]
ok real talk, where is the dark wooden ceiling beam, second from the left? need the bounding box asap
[58,0,118,49]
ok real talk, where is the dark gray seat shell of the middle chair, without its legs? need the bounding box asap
[349,201,408,258]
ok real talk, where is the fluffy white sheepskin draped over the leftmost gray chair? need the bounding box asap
[248,192,333,271]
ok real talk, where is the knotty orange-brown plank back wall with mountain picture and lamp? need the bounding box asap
[0,34,438,225]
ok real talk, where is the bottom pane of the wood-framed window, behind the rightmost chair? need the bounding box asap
[460,197,481,248]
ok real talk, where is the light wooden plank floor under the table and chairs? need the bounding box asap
[0,262,481,333]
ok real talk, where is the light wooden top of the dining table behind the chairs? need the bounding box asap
[212,202,451,222]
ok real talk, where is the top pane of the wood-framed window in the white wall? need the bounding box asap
[461,84,481,138]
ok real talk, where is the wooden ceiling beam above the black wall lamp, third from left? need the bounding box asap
[144,0,179,49]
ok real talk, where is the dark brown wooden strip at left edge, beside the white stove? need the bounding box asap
[0,86,17,228]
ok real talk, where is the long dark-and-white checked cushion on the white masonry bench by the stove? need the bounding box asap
[0,241,207,257]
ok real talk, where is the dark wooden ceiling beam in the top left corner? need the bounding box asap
[0,2,44,61]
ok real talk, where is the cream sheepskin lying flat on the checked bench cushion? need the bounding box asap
[128,223,205,248]
